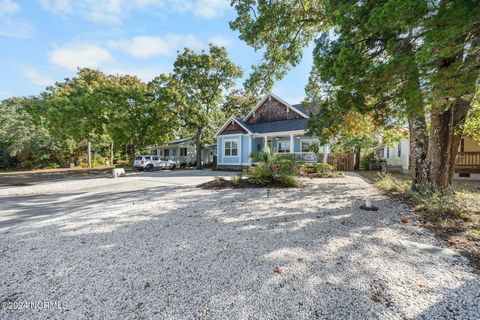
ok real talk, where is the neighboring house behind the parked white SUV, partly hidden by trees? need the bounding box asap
[150,138,216,165]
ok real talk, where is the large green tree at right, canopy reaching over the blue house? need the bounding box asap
[231,0,480,188]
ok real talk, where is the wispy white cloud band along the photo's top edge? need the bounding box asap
[39,0,230,24]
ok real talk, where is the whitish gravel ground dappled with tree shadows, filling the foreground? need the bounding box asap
[0,174,480,319]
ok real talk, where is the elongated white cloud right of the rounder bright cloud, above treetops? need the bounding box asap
[110,34,205,59]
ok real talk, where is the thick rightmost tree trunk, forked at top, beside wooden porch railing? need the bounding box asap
[428,98,470,192]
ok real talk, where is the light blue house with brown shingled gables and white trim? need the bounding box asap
[216,94,329,169]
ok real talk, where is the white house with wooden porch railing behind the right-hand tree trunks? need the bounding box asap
[374,137,480,180]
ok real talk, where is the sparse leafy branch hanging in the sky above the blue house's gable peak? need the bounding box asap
[230,0,328,92]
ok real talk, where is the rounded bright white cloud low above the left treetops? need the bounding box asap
[49,44,115,70]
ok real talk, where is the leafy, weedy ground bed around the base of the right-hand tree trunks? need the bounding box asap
[358,171,480,272]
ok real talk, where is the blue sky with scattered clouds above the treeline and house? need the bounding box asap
[0,0,312,103]
